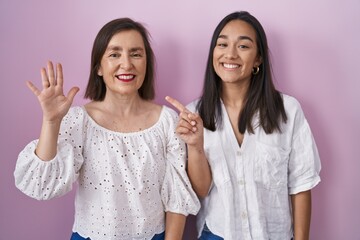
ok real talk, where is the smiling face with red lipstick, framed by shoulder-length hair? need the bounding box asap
[98,30,146,95]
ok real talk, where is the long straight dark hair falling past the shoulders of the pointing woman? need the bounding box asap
[197,11,287,134]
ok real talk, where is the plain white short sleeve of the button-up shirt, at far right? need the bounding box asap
[288,100,321,194]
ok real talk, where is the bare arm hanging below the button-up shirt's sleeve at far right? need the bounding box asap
[291,190,311,240]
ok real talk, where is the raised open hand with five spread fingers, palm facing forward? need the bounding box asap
[26,61,79,122]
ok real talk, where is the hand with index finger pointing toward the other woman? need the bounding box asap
[165,96,204,148]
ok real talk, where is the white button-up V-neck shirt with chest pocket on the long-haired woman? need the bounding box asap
[188,95,321,240]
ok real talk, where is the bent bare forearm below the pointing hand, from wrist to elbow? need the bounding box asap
[188,146,212,198]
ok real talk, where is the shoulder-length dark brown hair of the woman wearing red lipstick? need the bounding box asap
[85,18,155,101]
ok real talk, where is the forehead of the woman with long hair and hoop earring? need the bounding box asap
[219,20,256,40]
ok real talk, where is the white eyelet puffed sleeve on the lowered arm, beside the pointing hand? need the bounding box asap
[161,106,200,216]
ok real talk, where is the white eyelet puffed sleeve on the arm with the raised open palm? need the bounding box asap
[14,107,84,200]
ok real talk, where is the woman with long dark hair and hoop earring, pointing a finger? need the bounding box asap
[168,12,320,240]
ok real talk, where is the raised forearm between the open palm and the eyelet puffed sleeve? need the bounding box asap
[35,121,61,161]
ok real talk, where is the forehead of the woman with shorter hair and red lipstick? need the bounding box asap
[108,30,144,48]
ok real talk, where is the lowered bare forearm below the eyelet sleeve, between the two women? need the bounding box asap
[165,212,186,240]
